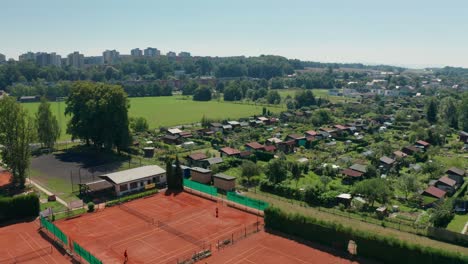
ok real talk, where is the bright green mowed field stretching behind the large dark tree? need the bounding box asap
[22,95,285,140]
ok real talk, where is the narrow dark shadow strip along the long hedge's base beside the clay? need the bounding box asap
[265,228,380,264]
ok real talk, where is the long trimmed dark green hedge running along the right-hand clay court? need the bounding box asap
[264,207,468,264]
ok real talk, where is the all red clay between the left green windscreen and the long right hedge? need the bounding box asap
[51,193,351,264]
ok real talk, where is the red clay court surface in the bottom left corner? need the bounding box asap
[0,221,71,264]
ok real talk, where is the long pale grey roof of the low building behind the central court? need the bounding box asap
[99,165,166,184]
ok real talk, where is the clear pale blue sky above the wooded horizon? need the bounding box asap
[0,0,468,67]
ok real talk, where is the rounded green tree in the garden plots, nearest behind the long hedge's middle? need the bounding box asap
[353,178,392,206]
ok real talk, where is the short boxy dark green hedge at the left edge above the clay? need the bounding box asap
[0,193,40,221]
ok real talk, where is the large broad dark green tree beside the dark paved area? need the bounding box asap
[65,82,130,151]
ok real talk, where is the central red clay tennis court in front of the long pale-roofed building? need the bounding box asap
[55,193,263,263]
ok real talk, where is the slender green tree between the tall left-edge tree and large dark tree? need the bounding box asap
[35,97,60,148]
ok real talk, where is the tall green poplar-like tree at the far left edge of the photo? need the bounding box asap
[0,97,36,188]
